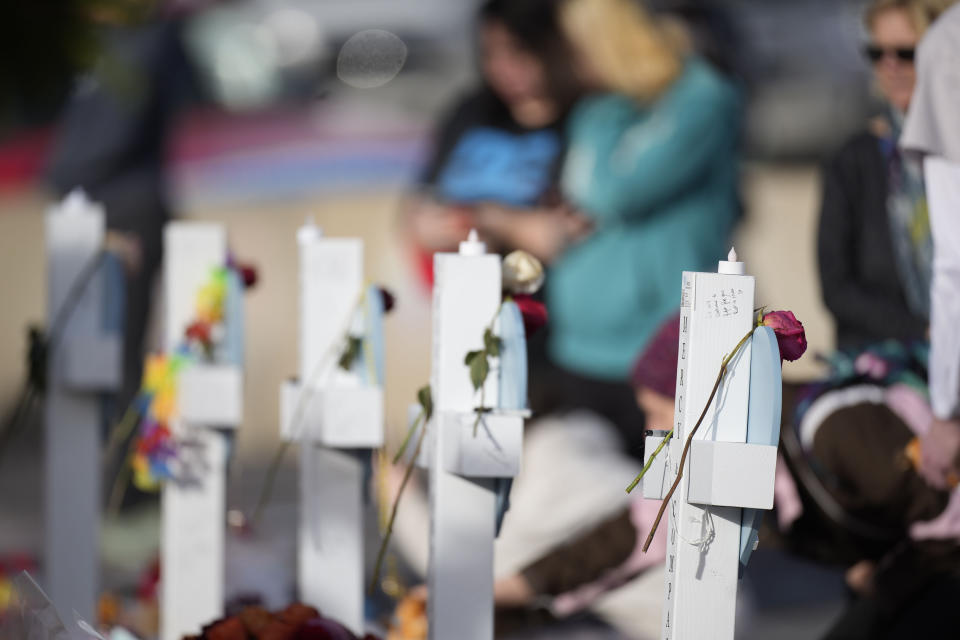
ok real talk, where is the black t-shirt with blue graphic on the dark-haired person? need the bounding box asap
[421,90,563,207]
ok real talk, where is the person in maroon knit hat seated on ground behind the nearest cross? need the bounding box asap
[384,317,679,638]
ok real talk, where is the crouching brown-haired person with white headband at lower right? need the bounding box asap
[776,341,960,640]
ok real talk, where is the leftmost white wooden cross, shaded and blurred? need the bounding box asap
[44,190,123,620]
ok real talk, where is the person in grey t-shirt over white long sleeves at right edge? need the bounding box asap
[901,2,960,496]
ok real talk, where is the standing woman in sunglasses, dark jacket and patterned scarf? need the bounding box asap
[818,0,944,348]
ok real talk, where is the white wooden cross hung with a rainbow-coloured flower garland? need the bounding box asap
[160,222,243,640]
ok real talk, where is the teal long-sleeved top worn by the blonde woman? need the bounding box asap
[547,57,740,381]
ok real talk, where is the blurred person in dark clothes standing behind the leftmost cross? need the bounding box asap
[46,0,196,476]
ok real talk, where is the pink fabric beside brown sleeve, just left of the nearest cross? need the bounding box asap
[553,498,667,617]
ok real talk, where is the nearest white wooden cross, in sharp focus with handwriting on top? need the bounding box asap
[644,250,780,640]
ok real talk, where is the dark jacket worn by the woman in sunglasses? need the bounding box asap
[817,132,927,347]
